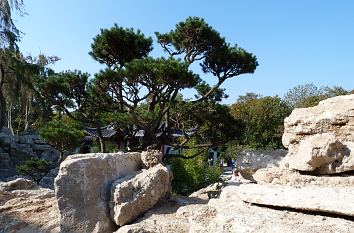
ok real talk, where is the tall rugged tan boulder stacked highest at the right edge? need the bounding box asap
[282,95,354,174]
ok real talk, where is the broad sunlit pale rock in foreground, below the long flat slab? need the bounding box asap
[117,179,354,233]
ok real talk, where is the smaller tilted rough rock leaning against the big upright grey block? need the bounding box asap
[110,164,171,226]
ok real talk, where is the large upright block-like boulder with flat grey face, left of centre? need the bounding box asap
[55,153,142,232]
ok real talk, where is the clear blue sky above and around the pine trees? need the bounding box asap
[15,0,354,104]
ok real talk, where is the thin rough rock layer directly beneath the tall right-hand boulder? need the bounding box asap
[253,168,354,189]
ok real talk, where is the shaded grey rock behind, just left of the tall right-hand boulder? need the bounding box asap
[236,149,287,180]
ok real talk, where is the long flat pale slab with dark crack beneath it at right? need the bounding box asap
[239,184,354,217]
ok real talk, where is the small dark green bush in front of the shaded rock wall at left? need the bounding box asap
[16,158,52,184]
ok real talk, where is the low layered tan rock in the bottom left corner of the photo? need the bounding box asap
[0,179,60,233]
